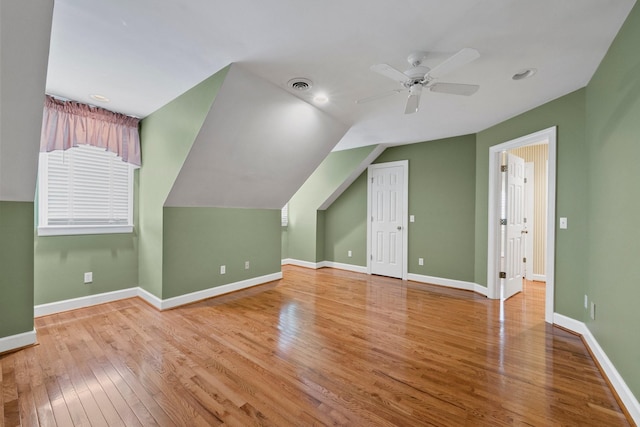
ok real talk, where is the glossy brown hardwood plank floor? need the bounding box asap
[0,267,629,426]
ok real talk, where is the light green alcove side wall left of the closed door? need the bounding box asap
[283,145,376,263]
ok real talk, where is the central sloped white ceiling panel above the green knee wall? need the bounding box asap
[165,64,348,209]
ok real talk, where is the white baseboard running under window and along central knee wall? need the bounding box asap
[34,272,282,317]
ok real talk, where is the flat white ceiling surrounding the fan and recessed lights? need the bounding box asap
[47,0,635,153]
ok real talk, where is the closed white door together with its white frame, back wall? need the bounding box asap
[367,160,409,280]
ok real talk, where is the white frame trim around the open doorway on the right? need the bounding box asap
[487,126,557,323]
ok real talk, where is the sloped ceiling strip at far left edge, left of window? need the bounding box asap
[0,0,53,201]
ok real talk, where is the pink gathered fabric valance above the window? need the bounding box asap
[40,95,140,166]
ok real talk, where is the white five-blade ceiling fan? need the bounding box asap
[356,47,480,114]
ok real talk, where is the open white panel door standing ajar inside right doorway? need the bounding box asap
[502,154,524,299]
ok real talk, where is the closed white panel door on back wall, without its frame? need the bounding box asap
[369,166,405,278]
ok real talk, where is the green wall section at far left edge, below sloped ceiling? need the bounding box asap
[0,201,34,337]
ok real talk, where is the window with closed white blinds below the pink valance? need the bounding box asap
[38,145,133,236]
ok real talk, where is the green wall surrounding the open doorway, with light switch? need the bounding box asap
[474,89,588,319]
